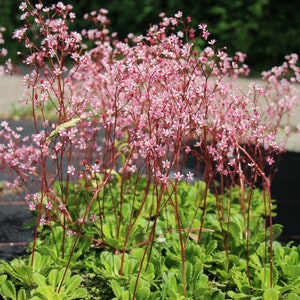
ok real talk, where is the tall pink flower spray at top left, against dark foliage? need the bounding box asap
[13,1,82,64]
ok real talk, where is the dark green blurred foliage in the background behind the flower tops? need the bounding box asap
[0,0,300,73]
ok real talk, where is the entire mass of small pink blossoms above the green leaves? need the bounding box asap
[0,1,300,234]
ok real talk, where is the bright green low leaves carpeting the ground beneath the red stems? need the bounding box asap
[0,181,300,300]
